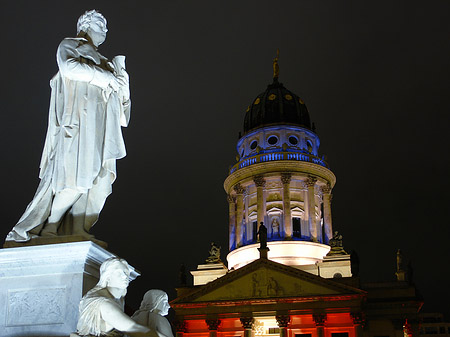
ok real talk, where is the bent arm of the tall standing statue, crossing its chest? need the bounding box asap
[56,38,117,89]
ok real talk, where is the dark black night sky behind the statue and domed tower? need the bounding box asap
[0,0,450,315]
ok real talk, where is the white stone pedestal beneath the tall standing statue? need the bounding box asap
[0,241,139,337]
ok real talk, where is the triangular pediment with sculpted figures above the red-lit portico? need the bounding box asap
[175,259,363,303]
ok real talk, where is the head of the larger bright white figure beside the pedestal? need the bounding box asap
[97,257,130,289]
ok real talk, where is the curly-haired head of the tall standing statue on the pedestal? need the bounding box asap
[77,9,108,47]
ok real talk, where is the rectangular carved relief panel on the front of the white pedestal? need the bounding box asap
[6,288,66,326]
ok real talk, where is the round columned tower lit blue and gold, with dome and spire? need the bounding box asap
[224,56,336,270]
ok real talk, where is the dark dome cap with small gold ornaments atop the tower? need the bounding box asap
[244,77,313,134]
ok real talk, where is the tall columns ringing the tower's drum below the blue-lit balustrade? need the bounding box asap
[228,172,333,250]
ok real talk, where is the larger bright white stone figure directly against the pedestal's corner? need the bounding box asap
[75,257,155,337]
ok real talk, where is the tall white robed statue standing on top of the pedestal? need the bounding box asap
[6,10,131,241]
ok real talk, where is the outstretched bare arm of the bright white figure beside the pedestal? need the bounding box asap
[100,301,151,336]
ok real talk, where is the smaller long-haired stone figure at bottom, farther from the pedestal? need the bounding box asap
[131,289,173,337]
